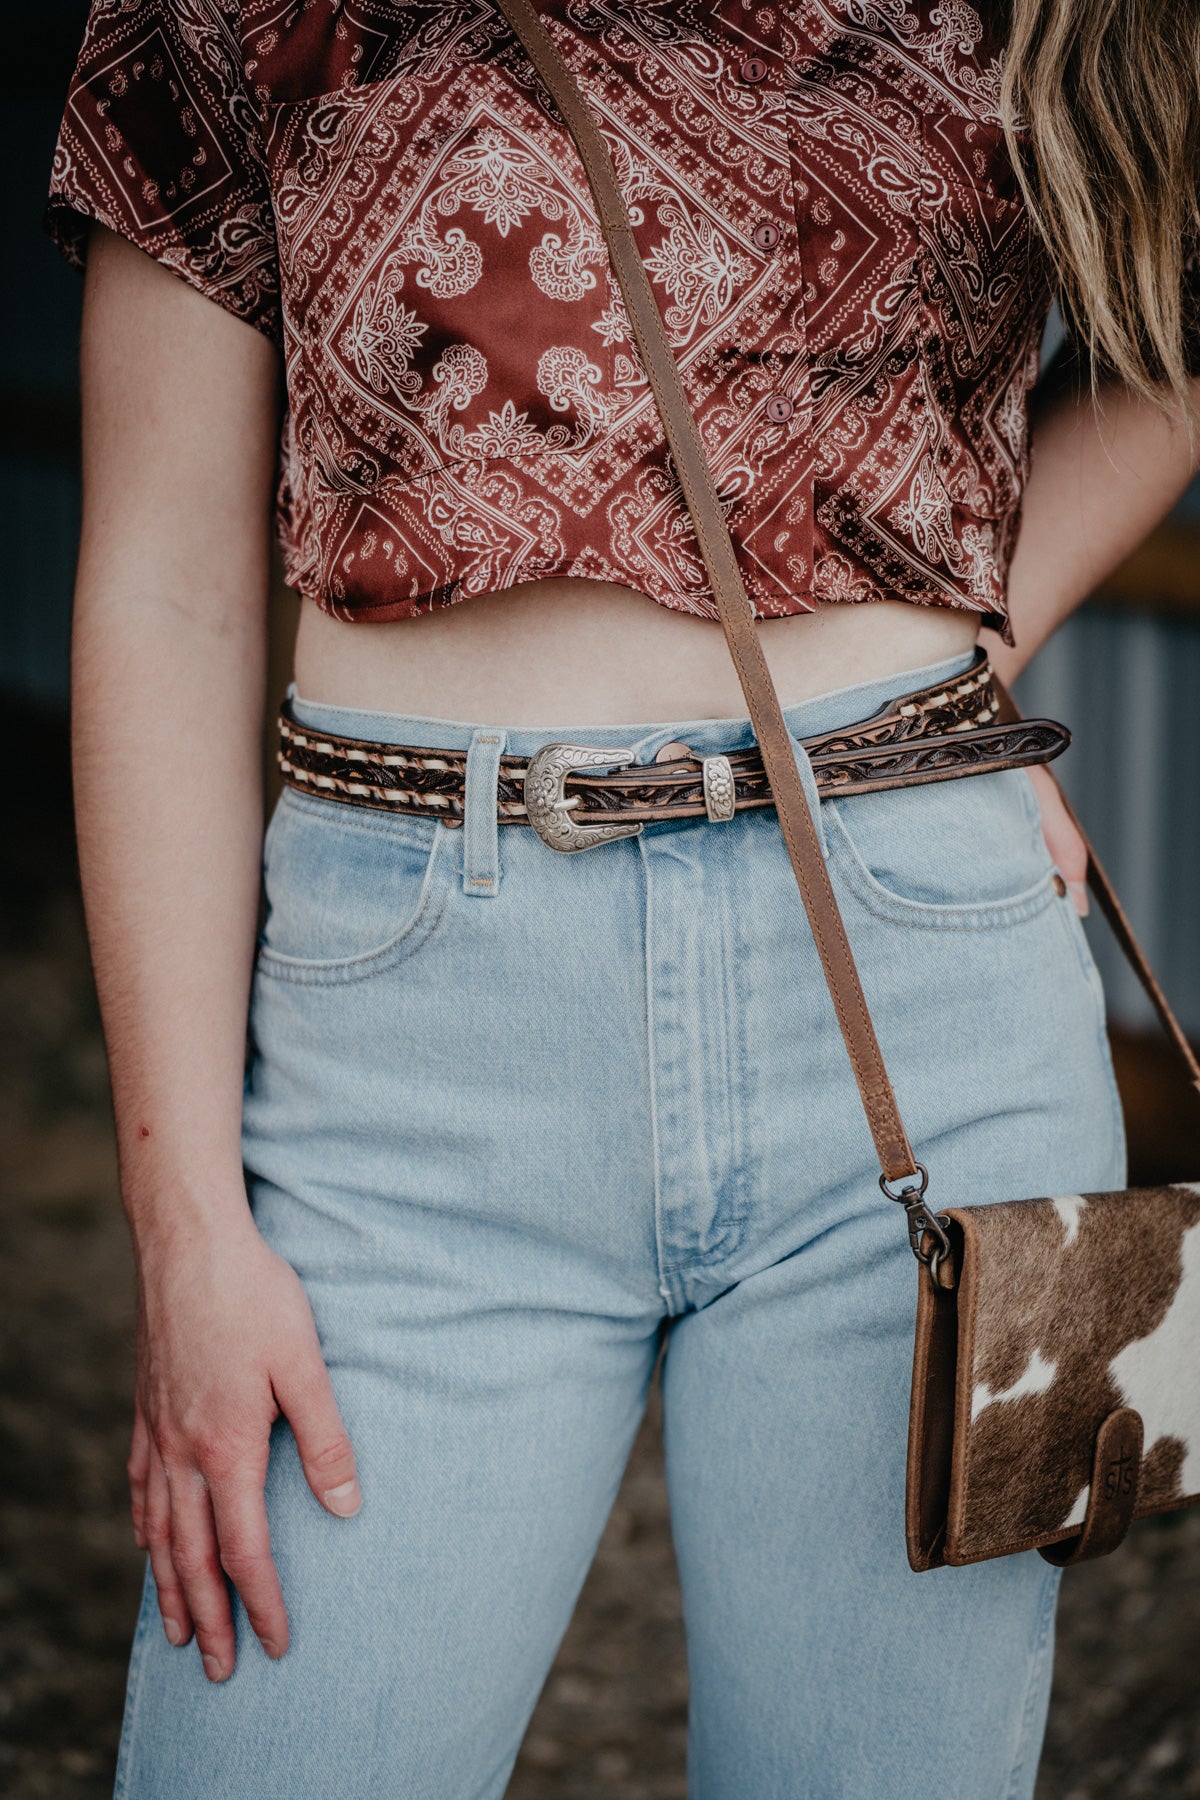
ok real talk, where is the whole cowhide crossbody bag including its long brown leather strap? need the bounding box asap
[498,0,1200,1570]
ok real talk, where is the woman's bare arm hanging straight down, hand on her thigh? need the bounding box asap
[72,227,360,1679]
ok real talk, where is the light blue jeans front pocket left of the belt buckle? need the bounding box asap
[257,788,453,986]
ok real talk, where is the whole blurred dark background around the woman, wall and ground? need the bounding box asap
[0,0,1200,1800]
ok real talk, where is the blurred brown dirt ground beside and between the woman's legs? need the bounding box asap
[0,752,1200,1800]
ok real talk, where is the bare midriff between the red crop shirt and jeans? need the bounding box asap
[295,580,979,725]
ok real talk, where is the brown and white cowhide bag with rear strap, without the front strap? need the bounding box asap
[907,759,1200,1570]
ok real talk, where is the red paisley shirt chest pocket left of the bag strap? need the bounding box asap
[266,55,622,491]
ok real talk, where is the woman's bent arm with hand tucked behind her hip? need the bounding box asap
[990,358,1200,913]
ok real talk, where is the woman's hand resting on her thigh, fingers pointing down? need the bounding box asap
[130,1213,362,1681]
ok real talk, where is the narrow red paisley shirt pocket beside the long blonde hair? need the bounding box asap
[918,113,1045,525]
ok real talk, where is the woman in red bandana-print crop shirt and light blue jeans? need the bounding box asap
[44,0,1200,1800]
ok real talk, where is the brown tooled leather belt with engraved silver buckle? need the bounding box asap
[279,650,1070,850]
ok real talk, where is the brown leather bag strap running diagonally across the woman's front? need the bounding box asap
[498,0,919,1181]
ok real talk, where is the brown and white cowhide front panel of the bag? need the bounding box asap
[948,1183,1200,1562]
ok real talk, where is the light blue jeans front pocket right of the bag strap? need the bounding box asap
[822,769,1056,931]
